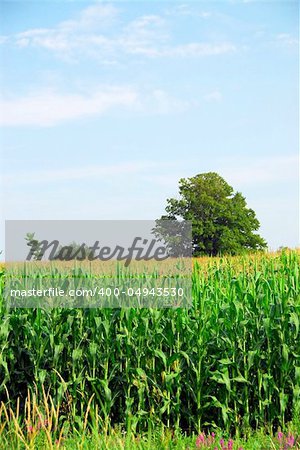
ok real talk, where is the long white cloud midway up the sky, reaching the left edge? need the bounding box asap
[0,86,198,127]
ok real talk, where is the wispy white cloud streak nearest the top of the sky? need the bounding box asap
[0,4,236,62]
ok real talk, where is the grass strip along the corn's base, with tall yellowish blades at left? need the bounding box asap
[0,391,300,450]
